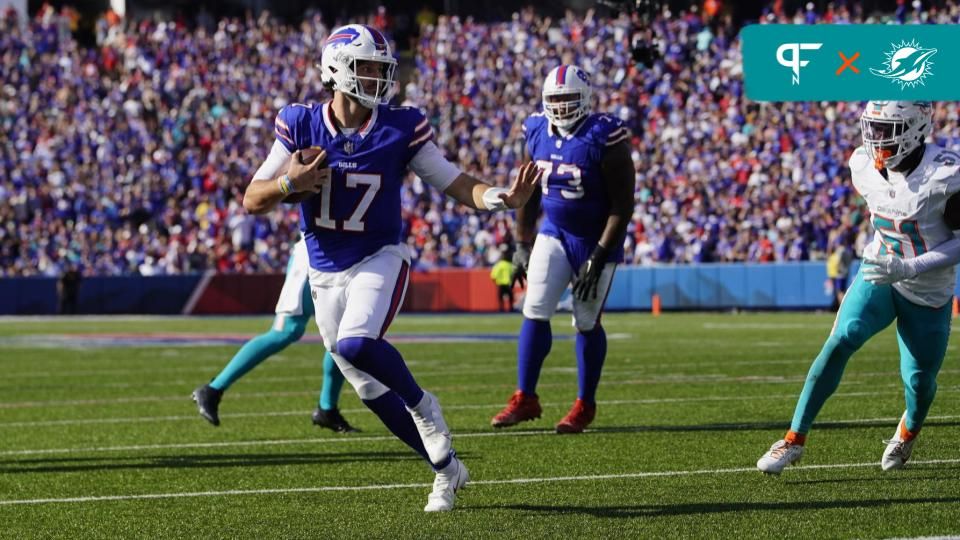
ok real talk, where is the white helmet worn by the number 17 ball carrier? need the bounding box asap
[320,24,397,109]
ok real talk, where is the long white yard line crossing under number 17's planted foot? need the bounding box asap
[0,458,960,506]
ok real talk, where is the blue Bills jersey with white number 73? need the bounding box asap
[523,113,630,270]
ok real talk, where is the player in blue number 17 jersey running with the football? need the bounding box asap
[243,24,540,512]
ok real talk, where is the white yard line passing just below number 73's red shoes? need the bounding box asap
[0,414,960,456]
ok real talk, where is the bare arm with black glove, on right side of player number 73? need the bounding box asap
[573,142,636,301]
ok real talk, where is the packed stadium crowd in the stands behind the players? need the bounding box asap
[0,2,960,276]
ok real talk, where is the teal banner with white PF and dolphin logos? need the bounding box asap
[740,24,960,101]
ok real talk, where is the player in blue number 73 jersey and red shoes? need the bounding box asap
[491,65,636,433]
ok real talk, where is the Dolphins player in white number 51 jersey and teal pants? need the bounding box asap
[757,101,960,474]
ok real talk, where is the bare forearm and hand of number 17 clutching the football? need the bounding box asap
[243,150,330,214]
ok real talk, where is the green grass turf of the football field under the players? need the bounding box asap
[0,314,960,538]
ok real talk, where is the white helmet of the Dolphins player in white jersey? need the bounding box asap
[860,101,933,169]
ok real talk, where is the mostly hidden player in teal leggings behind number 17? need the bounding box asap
[193,239,359,433]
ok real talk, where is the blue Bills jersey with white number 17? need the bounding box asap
[274,103,433,272]
